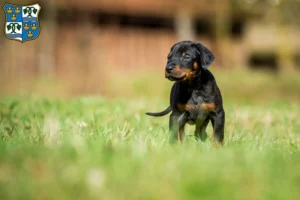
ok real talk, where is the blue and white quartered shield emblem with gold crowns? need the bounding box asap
[3,3,41,42]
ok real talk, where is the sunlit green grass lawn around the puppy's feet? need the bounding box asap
[0,71,300,200]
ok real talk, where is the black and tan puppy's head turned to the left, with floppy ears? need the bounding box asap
[165,41,214,81]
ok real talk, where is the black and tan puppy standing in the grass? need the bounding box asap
[146,41,225,143]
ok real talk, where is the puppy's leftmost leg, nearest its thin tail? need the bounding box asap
[169,112,187,143]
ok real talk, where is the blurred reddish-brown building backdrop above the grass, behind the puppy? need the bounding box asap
[0,0,300,96]
